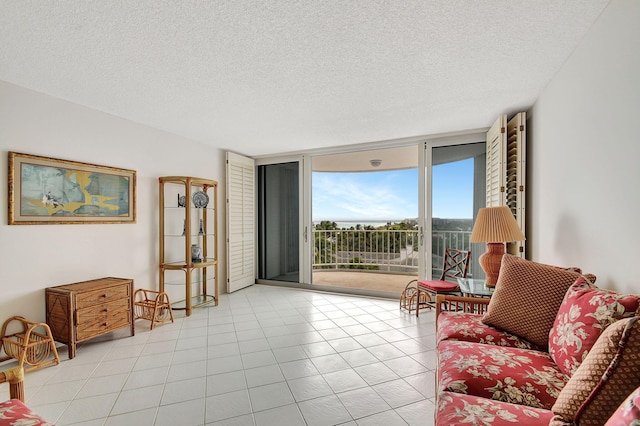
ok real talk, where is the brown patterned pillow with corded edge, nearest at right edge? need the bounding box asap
[552,317,640,425]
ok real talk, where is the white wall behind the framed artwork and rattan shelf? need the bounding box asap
[0,82,226,321]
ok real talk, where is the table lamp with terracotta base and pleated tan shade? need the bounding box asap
[469,206,525,287]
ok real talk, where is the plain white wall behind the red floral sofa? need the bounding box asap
[527,0,640,292]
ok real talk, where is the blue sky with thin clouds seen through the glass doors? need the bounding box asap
[312,159,473,222]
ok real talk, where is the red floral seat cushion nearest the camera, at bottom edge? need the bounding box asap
[436,392,553,426]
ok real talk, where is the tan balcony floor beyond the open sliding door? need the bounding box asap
[313,270,416,296]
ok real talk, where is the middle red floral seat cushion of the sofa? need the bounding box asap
[438,340,569,409]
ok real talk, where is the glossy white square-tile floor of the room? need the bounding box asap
[0,285,436,426]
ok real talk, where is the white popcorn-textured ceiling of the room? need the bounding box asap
[0,0,609,156]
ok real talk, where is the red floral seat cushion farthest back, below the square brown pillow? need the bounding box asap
[437,311,542,350]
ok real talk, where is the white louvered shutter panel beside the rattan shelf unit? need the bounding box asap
[227,152,256,293]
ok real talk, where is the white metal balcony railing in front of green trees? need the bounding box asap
[313,229,473,277]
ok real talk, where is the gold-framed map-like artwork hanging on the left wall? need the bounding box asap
[9,152,136,225]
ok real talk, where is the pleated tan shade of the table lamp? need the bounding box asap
[470,206,525,243]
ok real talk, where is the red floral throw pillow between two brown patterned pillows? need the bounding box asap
[549,277,640,376]
